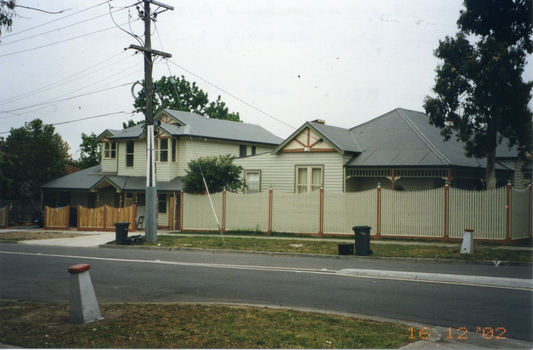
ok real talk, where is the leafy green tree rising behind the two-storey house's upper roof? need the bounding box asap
[133,76,240,122]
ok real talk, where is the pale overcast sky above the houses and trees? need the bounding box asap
[0,0,533,159]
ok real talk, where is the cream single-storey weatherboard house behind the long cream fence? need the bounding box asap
[235,108,531,193]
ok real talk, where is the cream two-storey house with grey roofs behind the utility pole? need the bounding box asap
[42,109,283,228]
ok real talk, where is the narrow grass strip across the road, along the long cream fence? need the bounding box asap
[139,235,533,262]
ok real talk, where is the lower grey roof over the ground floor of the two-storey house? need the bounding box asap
[41,165,183,192]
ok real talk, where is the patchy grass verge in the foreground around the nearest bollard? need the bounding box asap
[0,301,420,349]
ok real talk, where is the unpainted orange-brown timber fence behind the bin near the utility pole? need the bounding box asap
[78,205,137,232]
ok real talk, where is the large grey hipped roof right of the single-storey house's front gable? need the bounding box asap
[346,108,505,168]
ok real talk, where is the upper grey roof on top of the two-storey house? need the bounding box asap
[102,109,283,145]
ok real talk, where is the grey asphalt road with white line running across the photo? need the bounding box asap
[0,244,533,341]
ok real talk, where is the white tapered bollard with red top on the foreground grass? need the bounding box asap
[68,264,103,323]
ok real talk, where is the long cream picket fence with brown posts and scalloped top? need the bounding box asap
[180,185,533,243]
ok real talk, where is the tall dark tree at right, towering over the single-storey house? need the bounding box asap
[424,0,533,189]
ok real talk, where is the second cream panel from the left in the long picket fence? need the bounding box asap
[226,192,269,231]
